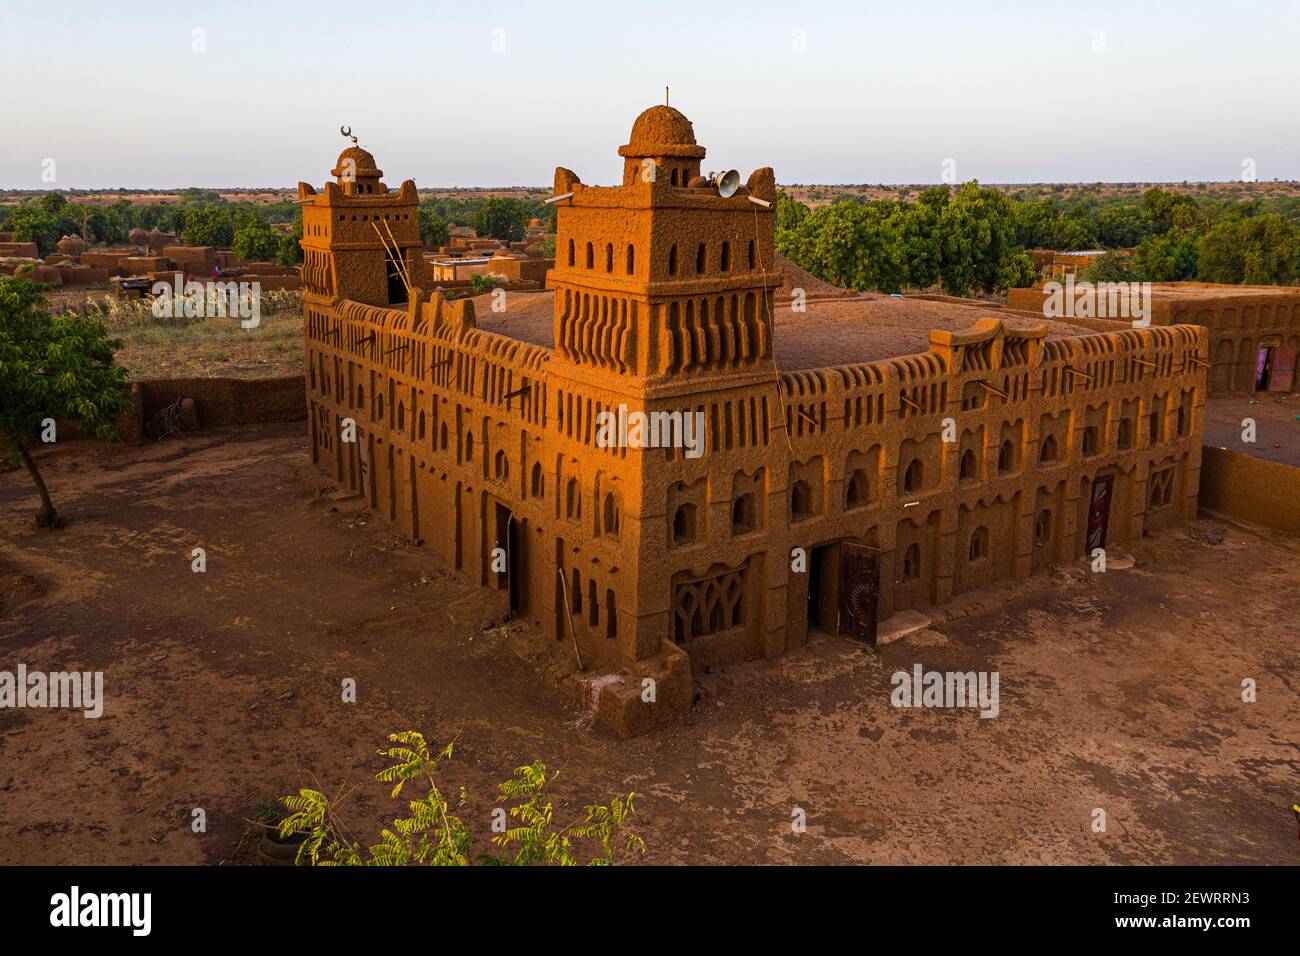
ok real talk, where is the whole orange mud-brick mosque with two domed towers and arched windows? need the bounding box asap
[298,107,1206,734]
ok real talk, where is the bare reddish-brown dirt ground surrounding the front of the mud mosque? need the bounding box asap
[0,425,1300,864]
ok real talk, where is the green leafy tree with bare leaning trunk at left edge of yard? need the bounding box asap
[0,277,131,527]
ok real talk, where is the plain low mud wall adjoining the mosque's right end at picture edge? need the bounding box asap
[1200,445,1300,535]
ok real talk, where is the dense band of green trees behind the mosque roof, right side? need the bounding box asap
[776,182,1300,295]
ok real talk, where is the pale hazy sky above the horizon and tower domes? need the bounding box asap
[0,0,1300,189]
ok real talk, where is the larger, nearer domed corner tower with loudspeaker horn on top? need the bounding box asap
[547,105,780,393]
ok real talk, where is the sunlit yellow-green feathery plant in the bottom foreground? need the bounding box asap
[280,731,646,866]
